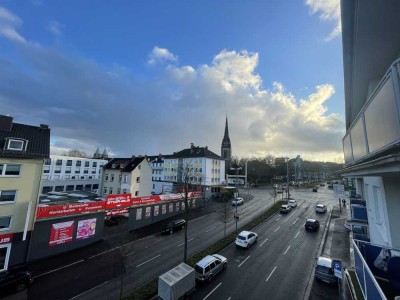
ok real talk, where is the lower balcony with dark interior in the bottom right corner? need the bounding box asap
[353,240,400,300]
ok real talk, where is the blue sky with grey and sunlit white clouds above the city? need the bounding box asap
[0,0,345,162]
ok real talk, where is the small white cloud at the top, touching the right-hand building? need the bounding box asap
[306,0,342,41]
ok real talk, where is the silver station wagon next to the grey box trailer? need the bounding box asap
[194,254,228,281]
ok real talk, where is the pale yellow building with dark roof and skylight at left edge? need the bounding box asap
[0,115,50,272]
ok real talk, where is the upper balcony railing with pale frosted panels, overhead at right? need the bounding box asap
[342,60,400,166]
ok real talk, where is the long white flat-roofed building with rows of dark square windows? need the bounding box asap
[41,155,108,194]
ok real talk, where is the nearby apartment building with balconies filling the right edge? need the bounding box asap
[341,0,400,299]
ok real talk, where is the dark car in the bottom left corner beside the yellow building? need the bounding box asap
[0,270,33,295]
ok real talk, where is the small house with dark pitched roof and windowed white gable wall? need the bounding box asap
[99,156,152,197]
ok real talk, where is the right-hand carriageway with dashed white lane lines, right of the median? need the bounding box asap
[189,188,336,299]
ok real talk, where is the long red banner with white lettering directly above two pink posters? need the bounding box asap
[36,201,105,219]
